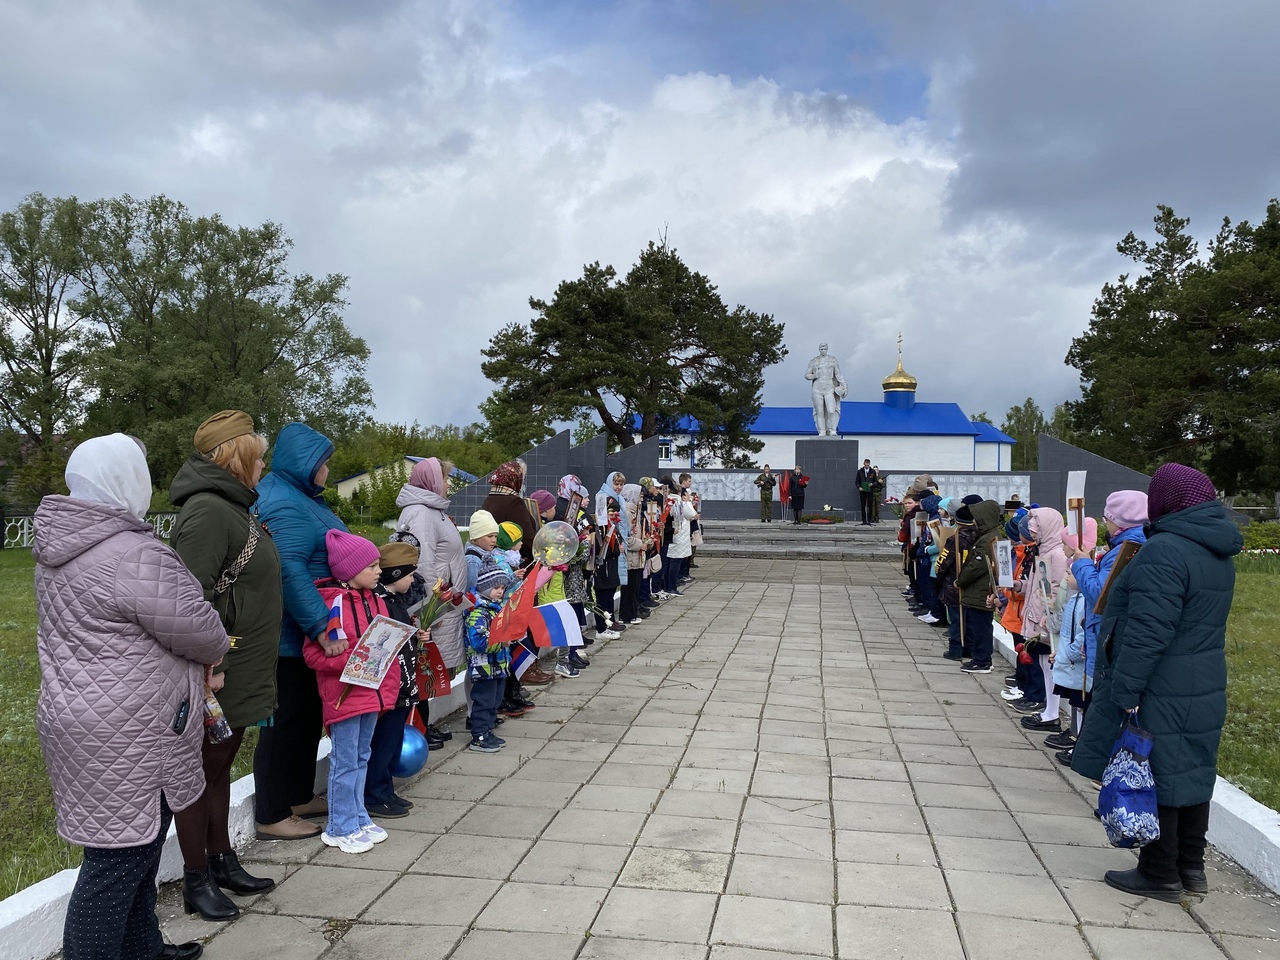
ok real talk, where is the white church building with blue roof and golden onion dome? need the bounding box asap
[658,346,1015,472]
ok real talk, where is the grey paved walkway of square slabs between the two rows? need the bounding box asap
[161,558,1280,960]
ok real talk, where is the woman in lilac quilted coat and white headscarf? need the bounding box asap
[33,434,227,960]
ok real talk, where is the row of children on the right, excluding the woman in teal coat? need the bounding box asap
[897,475,1147,767]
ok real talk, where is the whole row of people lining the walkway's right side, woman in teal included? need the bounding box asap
[899,463,1243,902]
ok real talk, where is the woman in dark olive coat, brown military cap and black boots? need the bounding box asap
[169,410,282,920]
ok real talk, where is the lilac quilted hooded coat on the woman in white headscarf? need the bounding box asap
[33,497,227,847]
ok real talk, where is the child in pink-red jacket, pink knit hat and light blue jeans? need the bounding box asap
[302,530,401,854]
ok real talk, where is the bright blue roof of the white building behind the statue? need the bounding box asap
[632,401,1015,443]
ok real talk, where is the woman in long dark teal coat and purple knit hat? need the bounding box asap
[1071,463,1244,902]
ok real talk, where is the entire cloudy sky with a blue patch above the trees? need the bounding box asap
[0,0,1280,424]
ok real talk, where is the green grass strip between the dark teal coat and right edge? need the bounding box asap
[1217,570,1280,810]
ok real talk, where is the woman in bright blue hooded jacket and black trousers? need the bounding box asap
[245,424,347,840]
